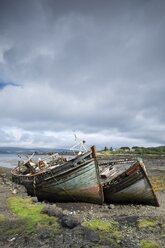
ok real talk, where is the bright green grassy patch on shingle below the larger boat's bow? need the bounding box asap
[82,219,122,247]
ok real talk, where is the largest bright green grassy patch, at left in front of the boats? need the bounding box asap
[8,196,59,232]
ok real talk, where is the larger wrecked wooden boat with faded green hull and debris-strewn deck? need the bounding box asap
[12,147,104,204]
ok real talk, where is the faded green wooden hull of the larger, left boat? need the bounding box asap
[12,151,104,204]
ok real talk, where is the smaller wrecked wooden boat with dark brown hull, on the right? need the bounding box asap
[100,159,159,206]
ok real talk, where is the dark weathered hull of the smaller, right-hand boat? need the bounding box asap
[103,161,159,206]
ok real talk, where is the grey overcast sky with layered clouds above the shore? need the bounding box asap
[0,0,165,148]
